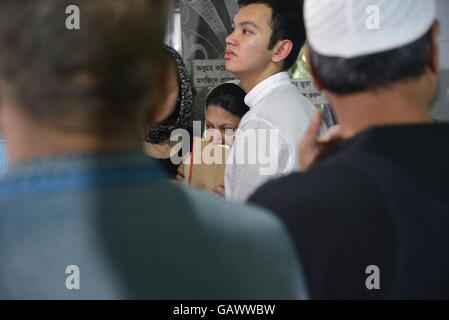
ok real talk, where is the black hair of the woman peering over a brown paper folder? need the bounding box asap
[206,83,249,118]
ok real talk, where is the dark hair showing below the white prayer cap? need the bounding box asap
[310,31,431,94]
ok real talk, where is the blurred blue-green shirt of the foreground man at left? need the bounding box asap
[0,152,307,300]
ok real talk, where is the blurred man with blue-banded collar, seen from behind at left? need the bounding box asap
[0,0,306,299]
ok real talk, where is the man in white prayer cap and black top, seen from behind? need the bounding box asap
[250,0,449,299]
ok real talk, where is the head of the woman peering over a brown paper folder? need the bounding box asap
[206,83,249,146]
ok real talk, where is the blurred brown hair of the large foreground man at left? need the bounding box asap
[0,0,167,131]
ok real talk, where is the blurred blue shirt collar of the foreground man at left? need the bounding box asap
[0,152,166,198]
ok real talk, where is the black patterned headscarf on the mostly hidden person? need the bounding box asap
[143,45,192,144]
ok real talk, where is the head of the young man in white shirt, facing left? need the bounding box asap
[225,0,305,75]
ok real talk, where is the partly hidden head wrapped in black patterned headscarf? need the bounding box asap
[144,45,193,144]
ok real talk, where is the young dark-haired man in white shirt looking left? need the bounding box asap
[224,0,314,201]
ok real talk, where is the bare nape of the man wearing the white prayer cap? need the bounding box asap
[327,80,434,139]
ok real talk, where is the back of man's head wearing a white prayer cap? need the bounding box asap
[304,0,439,103]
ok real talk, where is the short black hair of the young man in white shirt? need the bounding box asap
[238,0,306,70]
